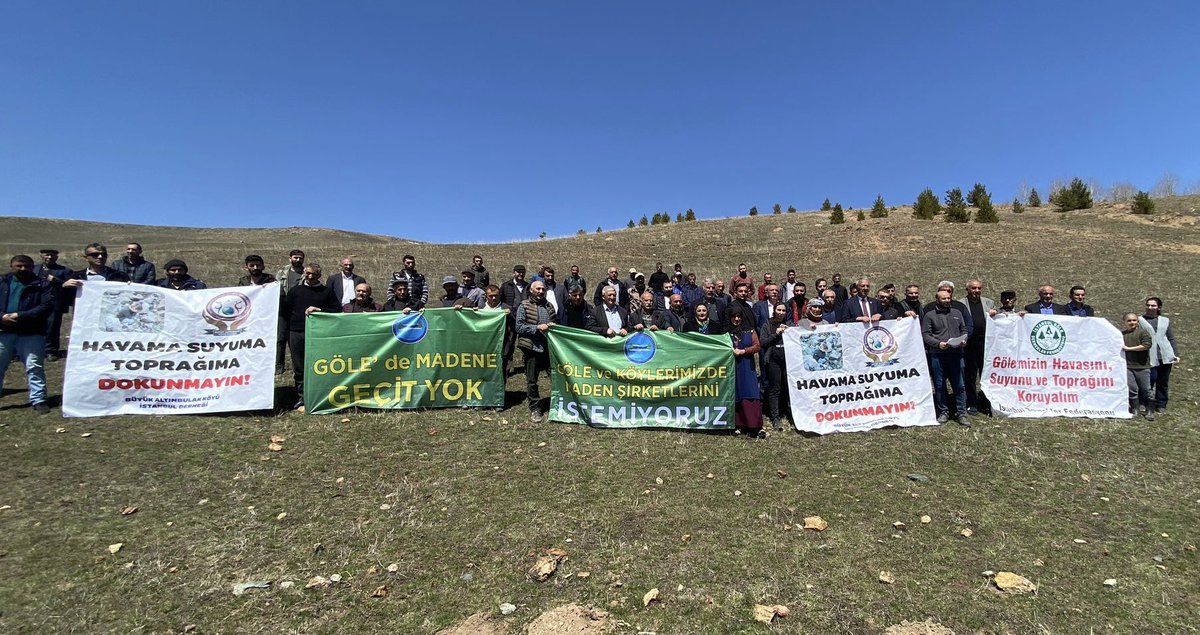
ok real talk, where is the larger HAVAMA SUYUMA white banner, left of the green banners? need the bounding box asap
[62,282,280,417]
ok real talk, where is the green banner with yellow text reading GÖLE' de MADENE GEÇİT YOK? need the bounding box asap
[304,308,505,414]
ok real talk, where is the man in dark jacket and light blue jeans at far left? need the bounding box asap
[0,254,54,414]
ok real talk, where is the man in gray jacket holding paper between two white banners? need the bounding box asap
[920,289,971,427]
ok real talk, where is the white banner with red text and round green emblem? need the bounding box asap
[979,313,1130,419]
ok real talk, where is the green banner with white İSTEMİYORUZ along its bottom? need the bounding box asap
[547,327,734,430]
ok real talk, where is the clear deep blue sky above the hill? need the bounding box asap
[0,0,1200,242]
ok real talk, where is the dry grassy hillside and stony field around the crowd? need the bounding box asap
[0,197,1200,634]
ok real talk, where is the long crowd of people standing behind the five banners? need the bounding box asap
[0,242,1180,436]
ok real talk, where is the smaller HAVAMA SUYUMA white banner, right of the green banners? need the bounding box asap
[784,318,937,435]
